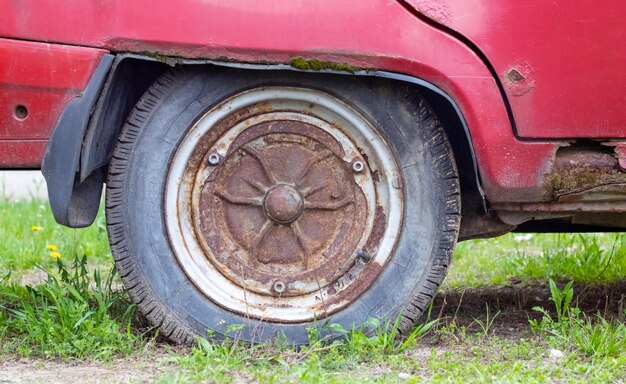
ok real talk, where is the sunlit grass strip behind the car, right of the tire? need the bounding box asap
[444,233,626,288]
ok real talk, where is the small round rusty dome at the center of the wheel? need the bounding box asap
[263,184,304,224]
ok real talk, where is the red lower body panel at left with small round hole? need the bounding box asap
[0,38,105,168]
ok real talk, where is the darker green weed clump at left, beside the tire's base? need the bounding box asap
[0,256,143,359]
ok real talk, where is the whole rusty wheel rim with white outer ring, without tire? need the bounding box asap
[165,87,403,322]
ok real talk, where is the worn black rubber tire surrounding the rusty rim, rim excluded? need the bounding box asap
[106,68,460,345]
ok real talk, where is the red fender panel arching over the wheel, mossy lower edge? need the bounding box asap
[0,0,561,225]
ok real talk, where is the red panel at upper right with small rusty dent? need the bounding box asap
[406,0,626,138]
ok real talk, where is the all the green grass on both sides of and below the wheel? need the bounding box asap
[0,200,626,383]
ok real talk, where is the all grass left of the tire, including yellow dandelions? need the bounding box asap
[0,199,145,359]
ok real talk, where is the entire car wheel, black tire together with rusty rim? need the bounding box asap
[106,68,460,344]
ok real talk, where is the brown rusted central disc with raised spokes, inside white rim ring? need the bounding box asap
[193,121,367,297]
